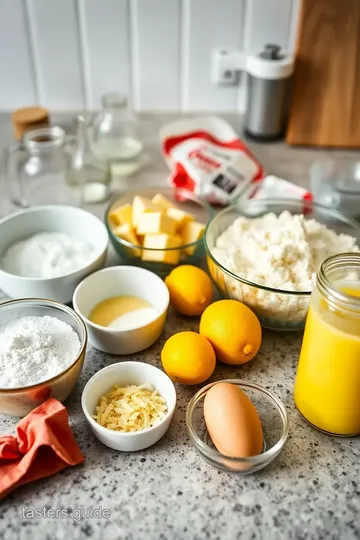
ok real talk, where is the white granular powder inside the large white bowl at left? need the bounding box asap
[1,232,96,279]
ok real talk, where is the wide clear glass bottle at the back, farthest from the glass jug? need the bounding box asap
[92,92,143,176]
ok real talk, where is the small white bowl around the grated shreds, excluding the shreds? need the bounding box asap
[81,362,176,452]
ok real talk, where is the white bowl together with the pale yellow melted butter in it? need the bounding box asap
[73,266,169,355]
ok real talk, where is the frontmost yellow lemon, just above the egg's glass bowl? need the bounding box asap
[161,332,216,384]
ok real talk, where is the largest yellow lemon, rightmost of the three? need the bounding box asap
[199,300,261,365]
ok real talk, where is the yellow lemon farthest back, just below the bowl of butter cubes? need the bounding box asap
[165,264,213,316]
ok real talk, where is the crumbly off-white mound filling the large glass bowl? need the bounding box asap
[211,211,360,322]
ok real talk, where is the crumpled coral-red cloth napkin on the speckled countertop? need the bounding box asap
[0,398,85,499]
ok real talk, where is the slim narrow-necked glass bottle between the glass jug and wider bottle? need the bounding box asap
[66,115,111,204]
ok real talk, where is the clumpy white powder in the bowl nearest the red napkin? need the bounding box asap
[0,315,80,388]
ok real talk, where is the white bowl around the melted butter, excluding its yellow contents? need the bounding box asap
[73,266,169,354]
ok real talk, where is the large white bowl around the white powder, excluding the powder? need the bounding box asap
[0,205,109,304]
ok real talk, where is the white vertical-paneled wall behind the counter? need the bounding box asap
[0,0,300,111]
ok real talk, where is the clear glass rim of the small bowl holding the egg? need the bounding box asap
[185,379,289,465]
